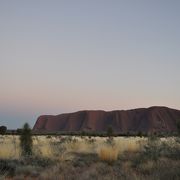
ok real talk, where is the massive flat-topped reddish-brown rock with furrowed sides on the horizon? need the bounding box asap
[33,107,180,133]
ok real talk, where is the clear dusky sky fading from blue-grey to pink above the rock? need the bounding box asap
[0,0,180,129]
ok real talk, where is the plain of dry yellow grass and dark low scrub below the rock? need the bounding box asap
[0,135,180,179]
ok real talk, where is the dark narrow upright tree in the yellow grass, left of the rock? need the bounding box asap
[20,123,33,156]
